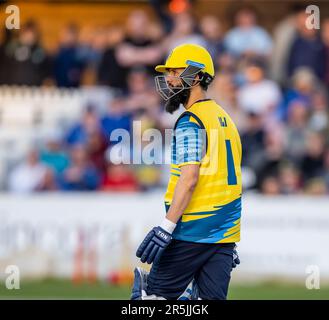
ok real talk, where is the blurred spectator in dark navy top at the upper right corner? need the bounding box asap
[287,11,326,79]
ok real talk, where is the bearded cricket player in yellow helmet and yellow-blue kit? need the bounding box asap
[131,44,242,300]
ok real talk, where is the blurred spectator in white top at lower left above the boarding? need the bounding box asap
[8,149,55,193]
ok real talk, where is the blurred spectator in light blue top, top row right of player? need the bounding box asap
[224,7,272,57]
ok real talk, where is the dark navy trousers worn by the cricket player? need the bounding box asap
[147,240,235,300]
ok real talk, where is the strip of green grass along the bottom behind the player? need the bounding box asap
[0,279,329,300]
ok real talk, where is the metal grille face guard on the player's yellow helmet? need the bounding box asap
[155,64,203,101]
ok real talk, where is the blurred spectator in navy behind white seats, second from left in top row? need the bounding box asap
[54,25,86,87]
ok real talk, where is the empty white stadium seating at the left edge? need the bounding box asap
[0,86,111,189]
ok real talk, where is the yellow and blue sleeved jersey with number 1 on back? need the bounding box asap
[165,99,242,243]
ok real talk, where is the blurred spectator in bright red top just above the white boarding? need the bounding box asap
[101,164,139,192]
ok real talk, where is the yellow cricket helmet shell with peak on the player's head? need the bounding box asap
[155,43,215,77]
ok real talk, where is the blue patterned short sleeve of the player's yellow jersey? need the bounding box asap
[174,115,204,167]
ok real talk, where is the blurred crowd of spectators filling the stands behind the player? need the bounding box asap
[0,1,329,195]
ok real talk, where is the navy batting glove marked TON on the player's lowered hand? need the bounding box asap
[136,227,172,264]
